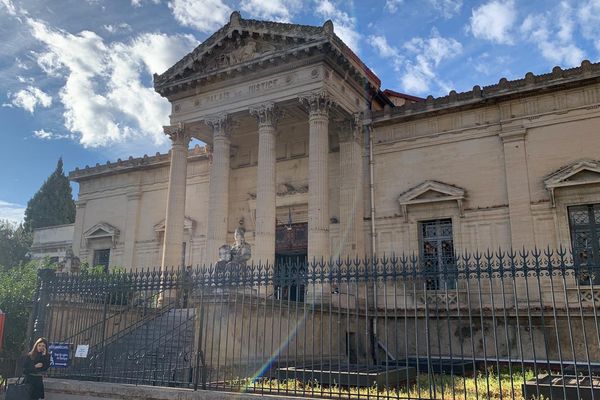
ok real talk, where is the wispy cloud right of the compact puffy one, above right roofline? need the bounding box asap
[521,2,585,67]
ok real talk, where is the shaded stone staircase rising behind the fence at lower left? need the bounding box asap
[72,309,195,386]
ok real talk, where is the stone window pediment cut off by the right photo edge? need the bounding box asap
[544,160,600,207]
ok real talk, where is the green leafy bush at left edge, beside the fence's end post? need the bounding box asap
[0,261,37,358]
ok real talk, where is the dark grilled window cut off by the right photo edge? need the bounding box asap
[568,204,600,285]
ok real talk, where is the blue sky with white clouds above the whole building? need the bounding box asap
[0,0,600,221]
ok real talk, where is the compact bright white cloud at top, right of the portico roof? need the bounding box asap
[469,0,517,44]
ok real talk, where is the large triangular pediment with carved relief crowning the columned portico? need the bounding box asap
[154,11,380,96]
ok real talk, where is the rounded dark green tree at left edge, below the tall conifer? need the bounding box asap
[0,220,31,269]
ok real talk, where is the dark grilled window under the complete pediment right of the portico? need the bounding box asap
[419,219,456,290]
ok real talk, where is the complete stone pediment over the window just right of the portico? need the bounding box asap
[398,180,465,221]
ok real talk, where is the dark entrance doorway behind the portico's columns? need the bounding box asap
[273,223,308,302]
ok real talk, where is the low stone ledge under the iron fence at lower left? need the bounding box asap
[44,378,314,400]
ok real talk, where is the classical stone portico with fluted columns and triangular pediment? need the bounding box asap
[155,12,379,267]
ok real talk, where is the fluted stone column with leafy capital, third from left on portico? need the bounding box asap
[250,103,281,264]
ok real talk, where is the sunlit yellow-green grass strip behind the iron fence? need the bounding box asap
[228,369,543,400]
